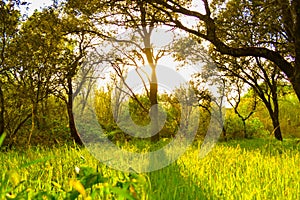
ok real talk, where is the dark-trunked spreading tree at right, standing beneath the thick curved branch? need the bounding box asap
[177,42,286,140]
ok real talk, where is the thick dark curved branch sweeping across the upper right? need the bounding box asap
[148,0,295,79]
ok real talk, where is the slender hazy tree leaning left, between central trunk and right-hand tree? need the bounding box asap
[172,37,227,140]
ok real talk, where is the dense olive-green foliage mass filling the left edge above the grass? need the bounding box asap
[0,1,82,147]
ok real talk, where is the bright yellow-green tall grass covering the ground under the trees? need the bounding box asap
[0,139,300,200]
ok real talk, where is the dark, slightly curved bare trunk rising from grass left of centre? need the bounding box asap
[67,76,83,145]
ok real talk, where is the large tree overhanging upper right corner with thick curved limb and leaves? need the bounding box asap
[147,0,300,100]
